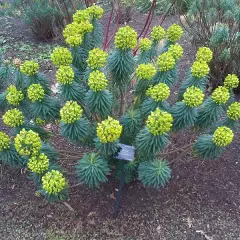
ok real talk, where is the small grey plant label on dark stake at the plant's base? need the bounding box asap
[114,144,135,218]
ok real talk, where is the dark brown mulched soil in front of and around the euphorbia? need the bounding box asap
[0,7,240,240]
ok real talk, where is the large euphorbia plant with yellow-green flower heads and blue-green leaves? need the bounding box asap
[0,5,240,201]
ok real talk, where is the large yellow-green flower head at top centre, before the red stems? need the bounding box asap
[114,26,137,50]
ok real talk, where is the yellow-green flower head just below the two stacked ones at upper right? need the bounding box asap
[183,86,204,108]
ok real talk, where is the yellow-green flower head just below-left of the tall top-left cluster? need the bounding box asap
[51,47,73,68]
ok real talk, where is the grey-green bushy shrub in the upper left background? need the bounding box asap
[11,0,83,40]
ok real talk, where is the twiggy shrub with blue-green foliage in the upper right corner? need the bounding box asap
[178,0,240,91]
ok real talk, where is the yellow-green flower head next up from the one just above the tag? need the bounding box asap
[88,70,108,92]
